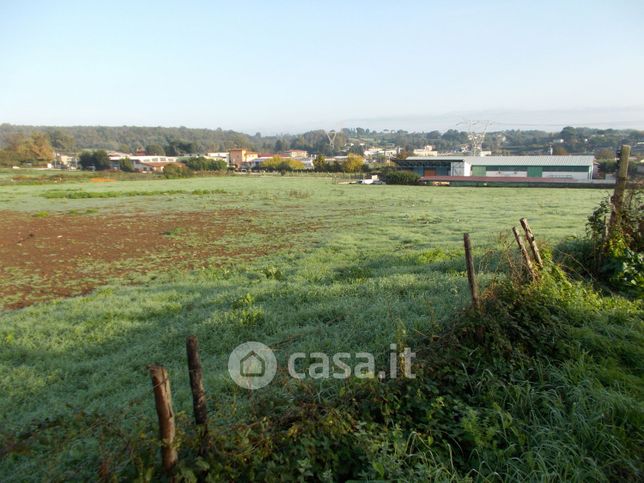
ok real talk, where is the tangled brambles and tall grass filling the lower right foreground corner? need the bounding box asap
[174,267,644,482]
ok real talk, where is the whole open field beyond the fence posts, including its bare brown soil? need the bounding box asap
[0,176,632,481]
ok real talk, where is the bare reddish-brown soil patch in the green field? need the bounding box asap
[0,210,298,308]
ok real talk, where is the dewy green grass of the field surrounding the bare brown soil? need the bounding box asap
[0,176,640,481]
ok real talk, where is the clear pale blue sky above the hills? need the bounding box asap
[0,0,644,134]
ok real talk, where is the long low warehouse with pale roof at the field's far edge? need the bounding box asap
[396,156,594,181]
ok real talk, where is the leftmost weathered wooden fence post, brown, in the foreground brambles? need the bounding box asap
[149,365,178,474]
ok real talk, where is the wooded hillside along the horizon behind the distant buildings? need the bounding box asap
[0,124,644,155]
